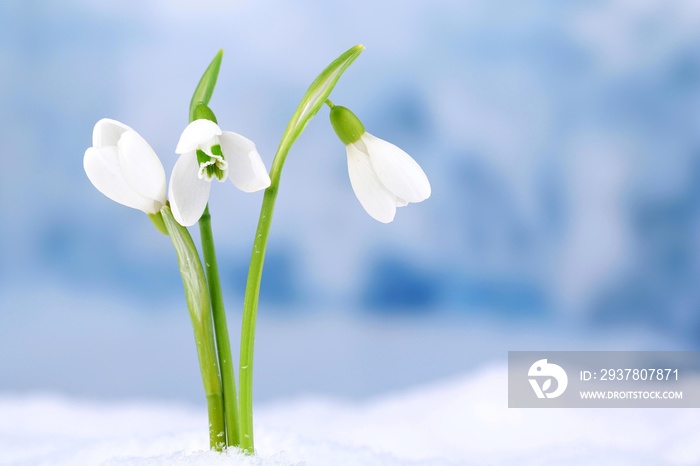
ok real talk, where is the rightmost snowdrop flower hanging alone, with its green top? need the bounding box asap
[327,101,430,223]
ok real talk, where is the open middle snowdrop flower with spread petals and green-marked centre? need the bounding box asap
[168,119,270,226]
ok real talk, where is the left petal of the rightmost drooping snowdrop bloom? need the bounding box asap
[346,144,397,223]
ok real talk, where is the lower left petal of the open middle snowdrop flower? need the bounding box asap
[168,152,211,227]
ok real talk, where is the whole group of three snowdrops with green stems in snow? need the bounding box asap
[83,44,431,453]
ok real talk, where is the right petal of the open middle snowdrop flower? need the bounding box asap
[219,131,270,193]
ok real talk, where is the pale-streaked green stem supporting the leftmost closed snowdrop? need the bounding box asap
[160,206,226,451]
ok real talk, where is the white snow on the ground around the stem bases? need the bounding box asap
[0,365,700,466]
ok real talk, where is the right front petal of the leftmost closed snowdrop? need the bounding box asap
[118,131,165,206]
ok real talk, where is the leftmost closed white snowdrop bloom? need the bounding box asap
[83,118,165,215]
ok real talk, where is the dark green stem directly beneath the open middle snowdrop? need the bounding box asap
[199,205,240,447]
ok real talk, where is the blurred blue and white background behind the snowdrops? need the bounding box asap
[0,0,700,402]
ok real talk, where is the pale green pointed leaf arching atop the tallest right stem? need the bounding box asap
[272,44,365,175]
